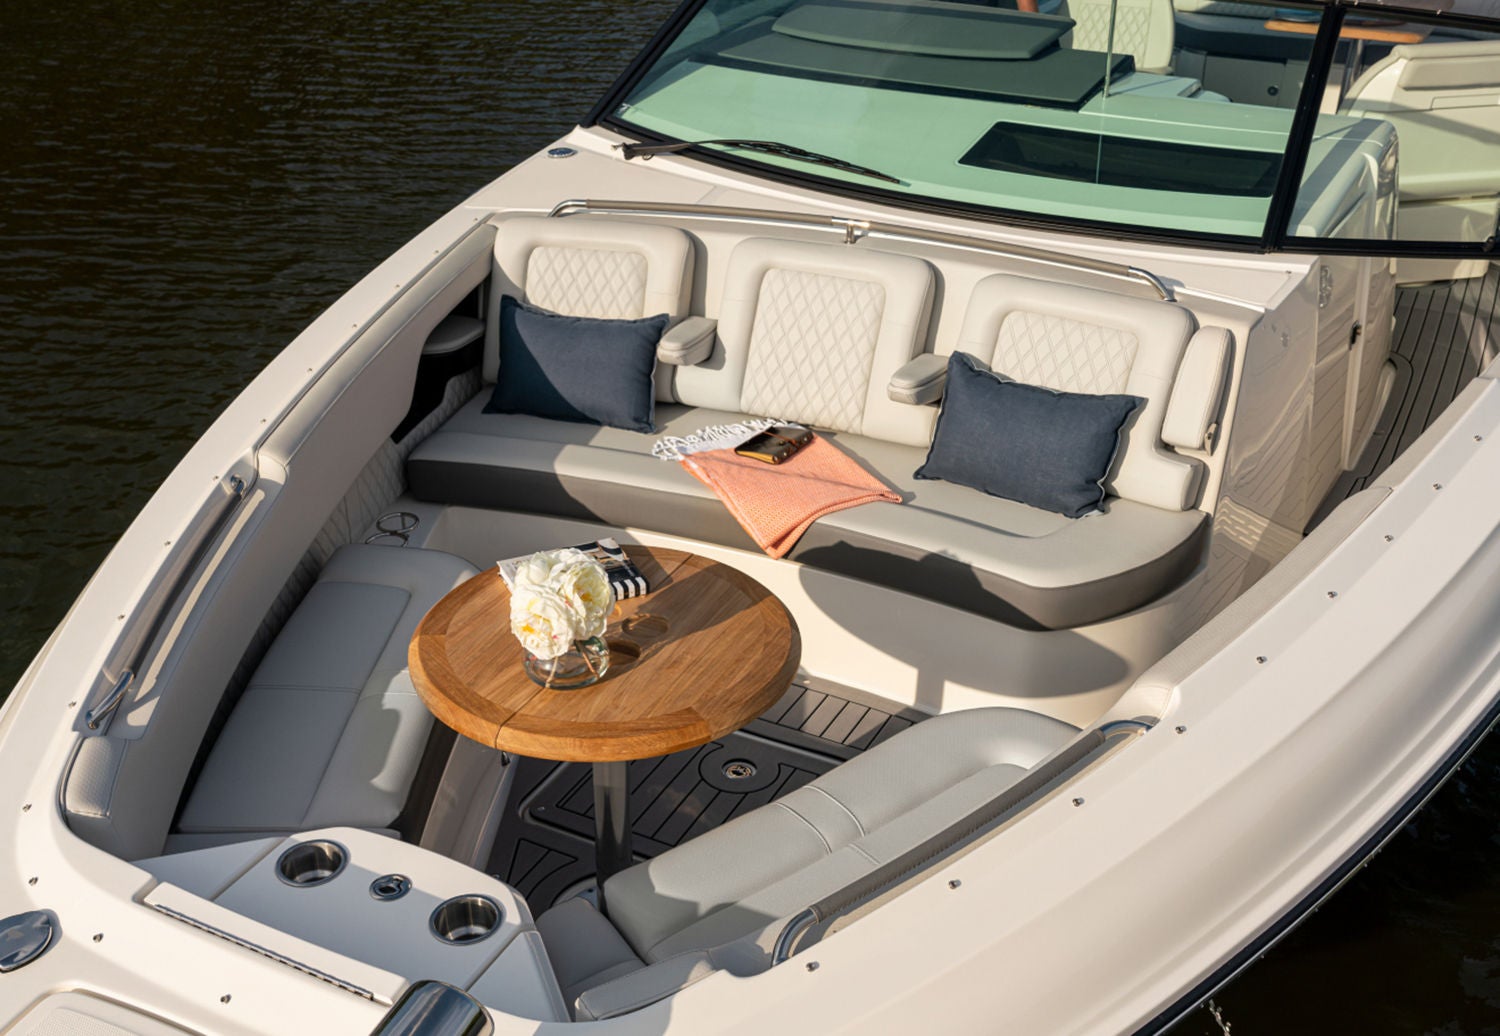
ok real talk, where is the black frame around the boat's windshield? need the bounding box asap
[582,0,1500,259]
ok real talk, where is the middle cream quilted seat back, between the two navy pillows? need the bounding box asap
[675,238,935,445]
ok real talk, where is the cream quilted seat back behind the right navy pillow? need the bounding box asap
[956,274,1199,511]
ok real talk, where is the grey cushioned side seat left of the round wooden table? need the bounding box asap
[179,544,476,835]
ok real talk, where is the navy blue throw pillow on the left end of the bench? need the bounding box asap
[485,295,671,432]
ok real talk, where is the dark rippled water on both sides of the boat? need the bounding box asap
[0,0,1500,1036]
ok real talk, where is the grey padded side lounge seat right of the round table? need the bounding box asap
[537,708,1079,1018]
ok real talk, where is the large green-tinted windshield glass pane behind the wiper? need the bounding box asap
[614,0,1356,240]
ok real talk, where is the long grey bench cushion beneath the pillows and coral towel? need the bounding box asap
[407,399,1208,630]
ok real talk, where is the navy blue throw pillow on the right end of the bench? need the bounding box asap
[917,352,1143,517]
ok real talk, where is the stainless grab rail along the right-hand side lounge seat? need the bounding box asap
[771,720,1152,967]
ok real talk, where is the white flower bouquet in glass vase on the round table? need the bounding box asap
[510,547,615,660]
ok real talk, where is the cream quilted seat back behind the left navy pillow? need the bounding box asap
[485,216,693,381]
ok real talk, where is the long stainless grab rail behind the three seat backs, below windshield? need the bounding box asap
[548,198,1178,303]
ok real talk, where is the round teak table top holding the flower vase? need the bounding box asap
[408,547,801,763]
